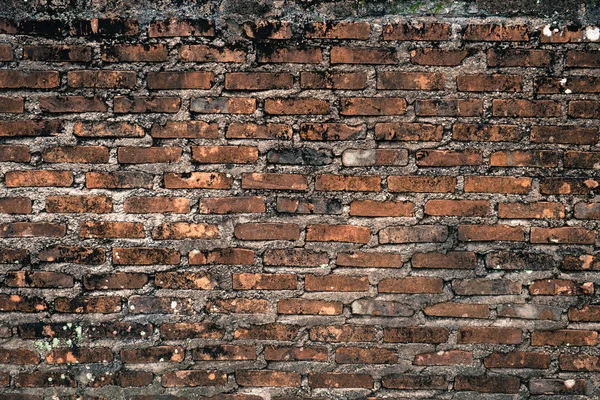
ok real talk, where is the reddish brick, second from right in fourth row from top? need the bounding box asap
[492,99,561,118]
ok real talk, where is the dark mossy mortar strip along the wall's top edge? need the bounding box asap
[0,0,600,25]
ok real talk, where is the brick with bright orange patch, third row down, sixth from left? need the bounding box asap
[377,72,446,90]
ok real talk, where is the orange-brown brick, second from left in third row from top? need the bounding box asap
[67,70,137,89]
